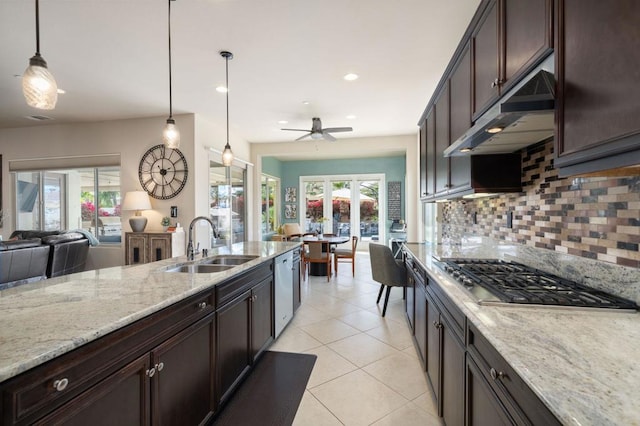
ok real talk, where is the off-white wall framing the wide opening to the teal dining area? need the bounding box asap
[251,135,423,245]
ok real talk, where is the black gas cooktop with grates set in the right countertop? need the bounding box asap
[436,258,638,311]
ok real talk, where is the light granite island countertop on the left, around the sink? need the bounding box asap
[0,241,300,382]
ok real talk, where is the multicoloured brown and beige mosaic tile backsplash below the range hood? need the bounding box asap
[440,141,640,268]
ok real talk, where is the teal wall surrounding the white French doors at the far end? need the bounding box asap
[262,156,406,238]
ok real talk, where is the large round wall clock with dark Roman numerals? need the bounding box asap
[138,145,188,200]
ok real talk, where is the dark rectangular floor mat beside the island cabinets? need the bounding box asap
[213,351,317,426]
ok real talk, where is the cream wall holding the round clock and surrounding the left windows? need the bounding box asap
[0,114,249,269]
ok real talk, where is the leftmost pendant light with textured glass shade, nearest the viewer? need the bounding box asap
[22,0,58,109]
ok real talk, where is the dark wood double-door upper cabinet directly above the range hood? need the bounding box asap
[471,0,553,120]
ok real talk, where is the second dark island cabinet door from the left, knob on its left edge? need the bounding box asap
[151,314,215,425]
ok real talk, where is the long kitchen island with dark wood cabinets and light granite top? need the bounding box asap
[0,242,300,424]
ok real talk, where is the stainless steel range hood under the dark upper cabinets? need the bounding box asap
[444,55,555,157]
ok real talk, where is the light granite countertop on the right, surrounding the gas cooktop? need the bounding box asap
[406,238,640,426]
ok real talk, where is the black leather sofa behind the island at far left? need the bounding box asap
[0,230,89,288]
